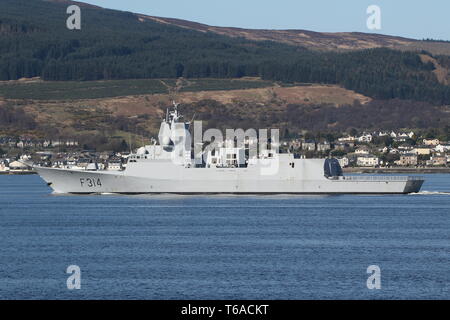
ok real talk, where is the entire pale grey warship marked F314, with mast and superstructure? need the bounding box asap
[33,104,424,194]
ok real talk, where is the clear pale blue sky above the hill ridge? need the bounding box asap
[79,0,450,40]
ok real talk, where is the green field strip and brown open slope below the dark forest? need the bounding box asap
[0,78,371,136]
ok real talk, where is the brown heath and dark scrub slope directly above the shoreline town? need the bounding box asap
[0,80,450,150]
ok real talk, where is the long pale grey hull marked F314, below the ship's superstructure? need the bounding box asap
[35,162,423,194]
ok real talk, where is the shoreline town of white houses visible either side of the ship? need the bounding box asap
[0,131,450,174]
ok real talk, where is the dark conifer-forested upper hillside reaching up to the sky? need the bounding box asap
[0,0,450,105]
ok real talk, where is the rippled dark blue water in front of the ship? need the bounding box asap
[0,175,450,299]
